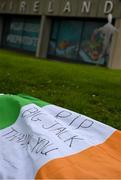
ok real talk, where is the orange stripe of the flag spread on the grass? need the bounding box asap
[35,131,121,180]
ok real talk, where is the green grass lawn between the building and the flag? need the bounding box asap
[0,50,121,129]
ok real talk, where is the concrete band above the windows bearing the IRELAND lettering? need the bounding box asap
[0,0,121,18]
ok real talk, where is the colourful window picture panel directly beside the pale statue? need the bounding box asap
[79,22,105,65]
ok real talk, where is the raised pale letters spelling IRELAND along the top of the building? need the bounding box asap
[0,0,116,15]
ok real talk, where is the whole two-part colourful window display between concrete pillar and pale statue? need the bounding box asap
[48,21,105,65]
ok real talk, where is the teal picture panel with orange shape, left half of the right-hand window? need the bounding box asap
[49,21,82,59]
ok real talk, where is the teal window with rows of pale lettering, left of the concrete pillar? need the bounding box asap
[5,18,40,52]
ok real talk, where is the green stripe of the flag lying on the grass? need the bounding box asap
[0,95,48,129]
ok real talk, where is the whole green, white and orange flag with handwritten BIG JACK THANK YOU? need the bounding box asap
[0,95,121,180]
